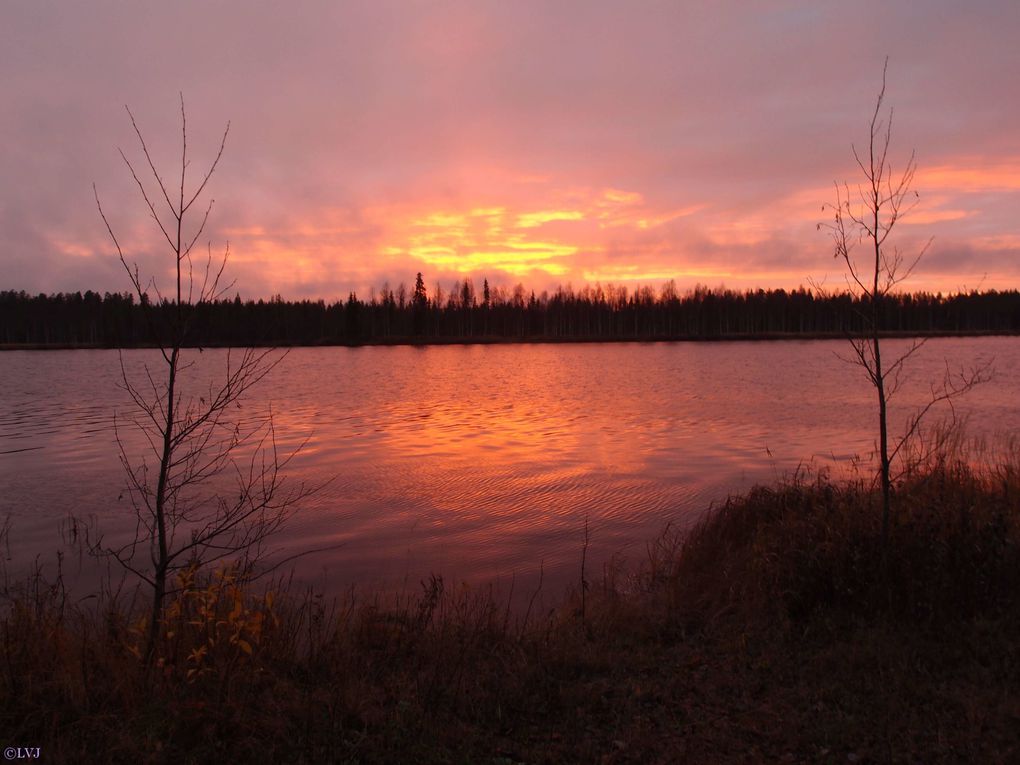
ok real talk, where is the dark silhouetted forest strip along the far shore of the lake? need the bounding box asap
[0,274,1020,347]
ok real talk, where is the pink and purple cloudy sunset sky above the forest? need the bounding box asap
[0,0,1020,300]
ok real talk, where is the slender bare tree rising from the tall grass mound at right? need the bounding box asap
[819,58,990,543]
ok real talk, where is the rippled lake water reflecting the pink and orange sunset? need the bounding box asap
[0,338,1020,592]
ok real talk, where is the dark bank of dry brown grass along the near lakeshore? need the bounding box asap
[0,455,1020,764]
